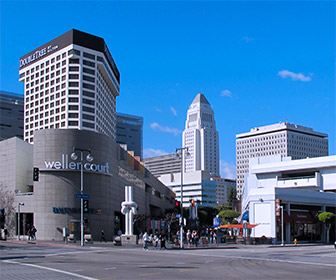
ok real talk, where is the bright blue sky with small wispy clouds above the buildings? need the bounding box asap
[0,0,336,178]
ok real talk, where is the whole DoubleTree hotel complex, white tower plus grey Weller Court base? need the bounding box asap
[4,30,175,240]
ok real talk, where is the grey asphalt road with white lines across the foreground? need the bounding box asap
[0,243,336,280]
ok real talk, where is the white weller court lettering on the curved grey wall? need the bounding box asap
[44,154,110,174]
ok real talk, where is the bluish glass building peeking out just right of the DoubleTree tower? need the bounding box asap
[116,113,143,159]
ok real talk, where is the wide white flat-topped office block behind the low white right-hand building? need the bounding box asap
[236,122,328,197]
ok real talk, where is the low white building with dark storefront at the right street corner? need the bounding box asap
[242,155,336,243]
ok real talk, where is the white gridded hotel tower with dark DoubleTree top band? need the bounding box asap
[19,29,120,143]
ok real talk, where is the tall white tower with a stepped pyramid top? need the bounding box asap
[182,93,219,176]
